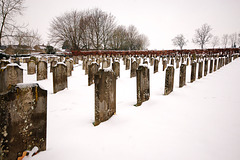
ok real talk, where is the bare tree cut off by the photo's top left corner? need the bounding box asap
[0,0,24,46]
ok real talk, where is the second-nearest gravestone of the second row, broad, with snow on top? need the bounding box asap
[53,62,67,93]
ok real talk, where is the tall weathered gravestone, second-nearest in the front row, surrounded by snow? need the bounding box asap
[93,69,116,126]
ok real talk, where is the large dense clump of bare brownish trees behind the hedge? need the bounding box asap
[50,8,149,50]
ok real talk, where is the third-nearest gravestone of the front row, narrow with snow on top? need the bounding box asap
[136,65,150,106]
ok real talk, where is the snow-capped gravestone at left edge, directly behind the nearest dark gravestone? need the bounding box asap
[0,64,23,93]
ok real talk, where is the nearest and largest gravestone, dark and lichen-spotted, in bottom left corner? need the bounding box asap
[0,83,47,160]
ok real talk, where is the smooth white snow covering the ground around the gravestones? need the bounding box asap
[22,59,240,160]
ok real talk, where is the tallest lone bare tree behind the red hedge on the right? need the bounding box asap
[192,23,212,49]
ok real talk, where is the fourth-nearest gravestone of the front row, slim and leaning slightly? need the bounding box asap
[164,66,174,95]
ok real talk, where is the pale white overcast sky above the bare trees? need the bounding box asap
[17,0,240,50]
